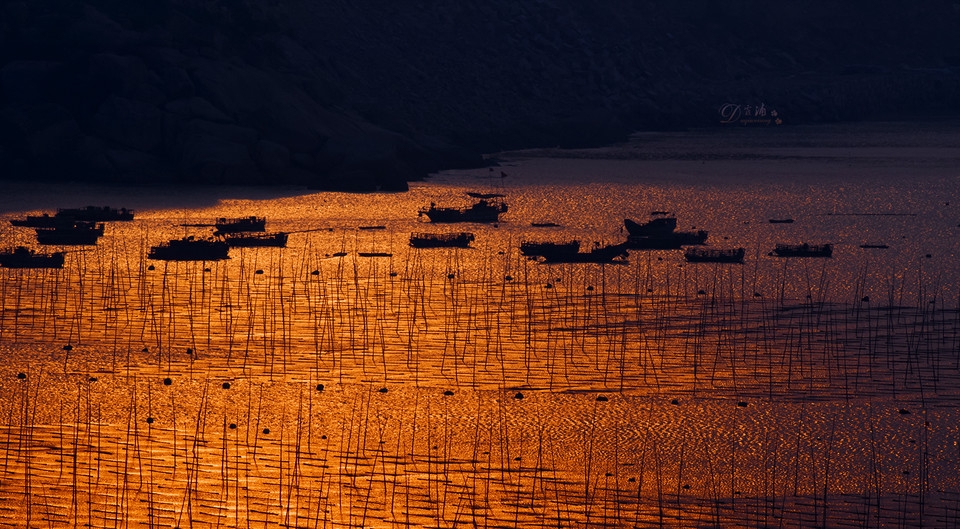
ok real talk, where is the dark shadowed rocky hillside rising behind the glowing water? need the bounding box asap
[0,0,960,191]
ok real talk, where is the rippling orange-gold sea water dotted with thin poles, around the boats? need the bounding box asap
[0,124,960,527]
